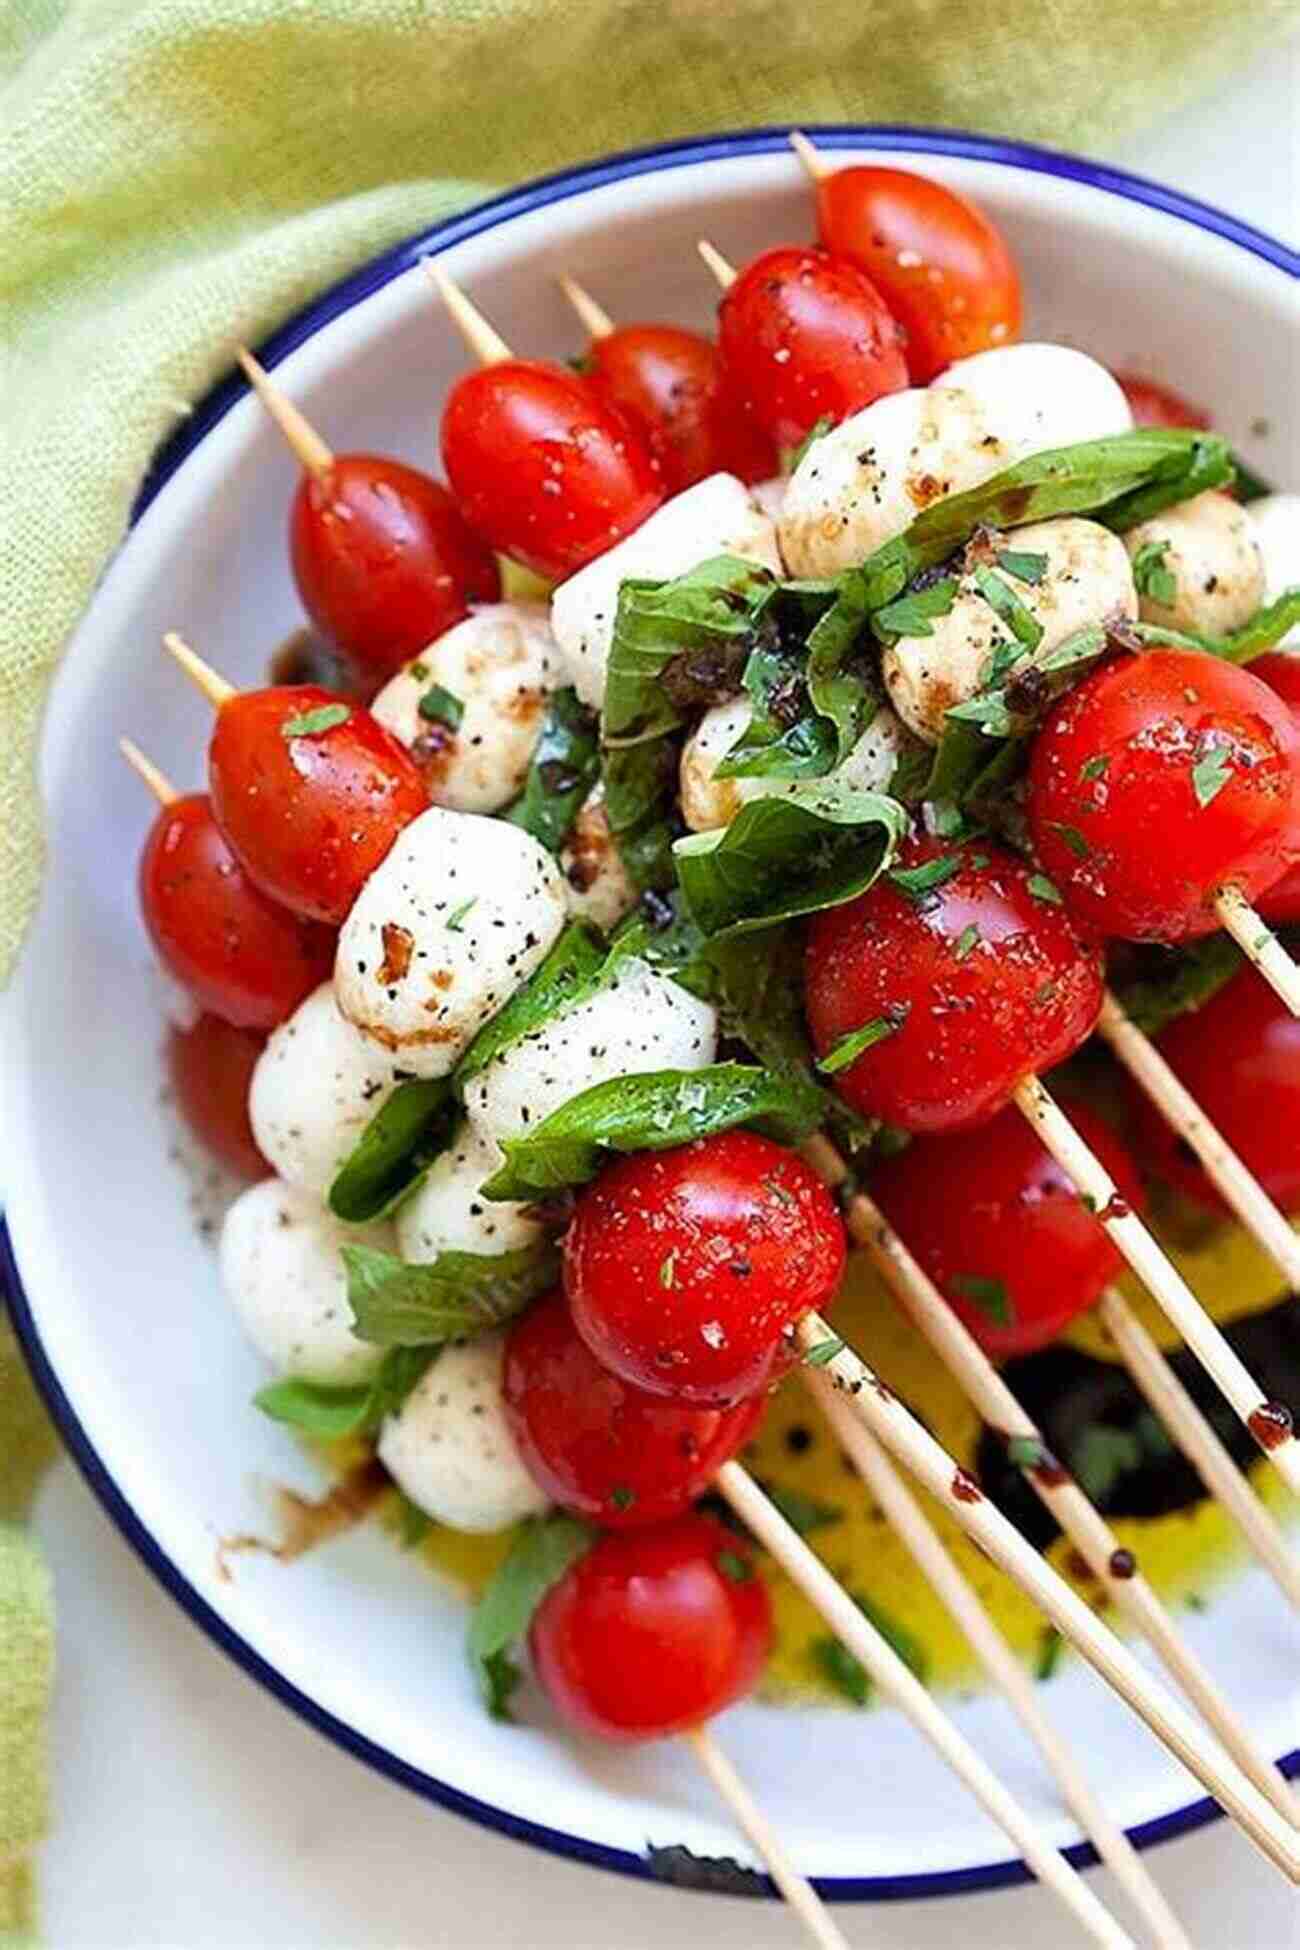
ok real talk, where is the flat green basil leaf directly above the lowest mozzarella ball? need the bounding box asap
[339,1240,559,1347]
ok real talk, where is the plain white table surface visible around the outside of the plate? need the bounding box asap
[20,43,1300,1950]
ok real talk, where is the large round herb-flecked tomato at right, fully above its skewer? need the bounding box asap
[1029,647,1300,942]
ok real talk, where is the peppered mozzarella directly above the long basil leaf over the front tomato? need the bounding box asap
[466,956,717,1145]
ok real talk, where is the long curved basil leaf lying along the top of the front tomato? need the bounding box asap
[483,1063,822,1201]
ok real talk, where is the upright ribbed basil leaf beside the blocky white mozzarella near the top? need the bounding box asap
[604,556,778,745]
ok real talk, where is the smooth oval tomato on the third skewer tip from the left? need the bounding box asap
[288,454,501,681]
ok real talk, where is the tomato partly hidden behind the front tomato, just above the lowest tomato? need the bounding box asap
[503,1293,762,1531]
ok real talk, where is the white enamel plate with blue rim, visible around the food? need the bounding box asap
[0,129,1300,1897]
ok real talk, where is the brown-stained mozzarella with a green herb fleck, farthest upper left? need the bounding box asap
[370,603,559,813]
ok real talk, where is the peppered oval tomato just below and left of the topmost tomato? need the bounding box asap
[717,246,908,449]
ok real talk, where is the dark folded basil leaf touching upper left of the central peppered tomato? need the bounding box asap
[672,780,908,934]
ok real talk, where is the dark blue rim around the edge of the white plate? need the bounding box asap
[0,123,1300,1901]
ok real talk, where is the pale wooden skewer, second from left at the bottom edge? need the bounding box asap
[715,1466,1128,1944]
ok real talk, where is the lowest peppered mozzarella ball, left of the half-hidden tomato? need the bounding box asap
[378,1332,546,1531]
